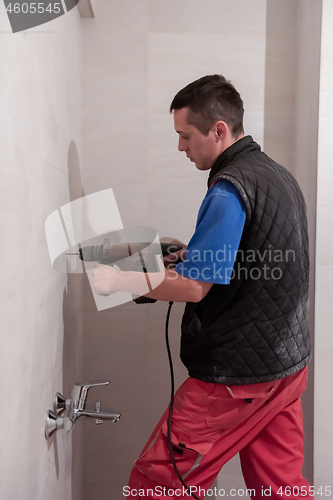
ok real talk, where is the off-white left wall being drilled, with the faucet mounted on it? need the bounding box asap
[0,6,81,500]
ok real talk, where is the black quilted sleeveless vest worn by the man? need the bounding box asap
[181,136,310,385]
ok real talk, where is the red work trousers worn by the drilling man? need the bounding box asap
[125,368,313,500]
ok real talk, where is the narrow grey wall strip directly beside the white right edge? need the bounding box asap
[291,0,322,485]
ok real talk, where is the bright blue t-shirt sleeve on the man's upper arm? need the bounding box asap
[175,180,246,285]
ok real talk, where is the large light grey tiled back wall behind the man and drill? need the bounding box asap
[83,0,266,500]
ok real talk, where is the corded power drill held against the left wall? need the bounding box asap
[76,238,182,304]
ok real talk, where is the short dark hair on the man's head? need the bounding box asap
[170,75,244,137]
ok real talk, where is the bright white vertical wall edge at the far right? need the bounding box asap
[314,0,333,487]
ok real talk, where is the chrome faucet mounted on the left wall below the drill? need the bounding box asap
[45,380,121,438]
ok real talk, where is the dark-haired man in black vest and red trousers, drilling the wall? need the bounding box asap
[95,75,312,499]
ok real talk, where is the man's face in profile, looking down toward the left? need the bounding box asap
[173,108,222,170]
